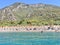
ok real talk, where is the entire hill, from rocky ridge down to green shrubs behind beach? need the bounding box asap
[0,2,60,26]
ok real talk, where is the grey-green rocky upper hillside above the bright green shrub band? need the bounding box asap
[0,2,60,25]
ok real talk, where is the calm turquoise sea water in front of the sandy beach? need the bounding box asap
[0,32,60,45]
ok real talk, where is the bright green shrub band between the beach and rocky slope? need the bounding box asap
[0,19,60,26]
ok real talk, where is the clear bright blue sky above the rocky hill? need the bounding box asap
[0,0,60,9]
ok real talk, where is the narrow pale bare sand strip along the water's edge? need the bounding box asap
[0,30,60,33]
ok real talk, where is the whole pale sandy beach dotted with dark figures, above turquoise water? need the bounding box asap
[0,26,60,32]
